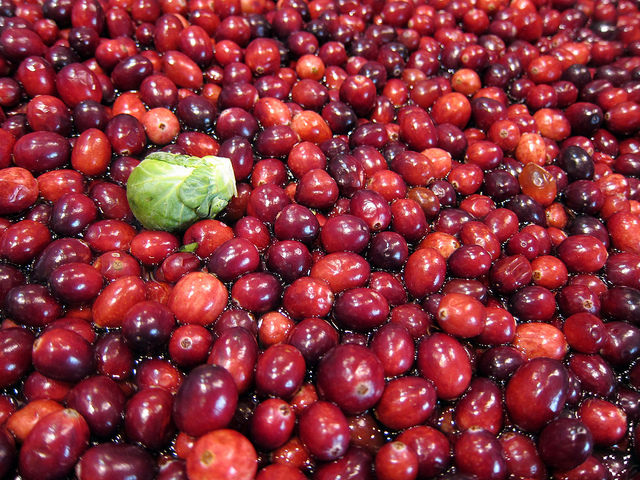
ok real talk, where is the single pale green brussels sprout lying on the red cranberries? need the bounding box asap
[127,152,237,231]
